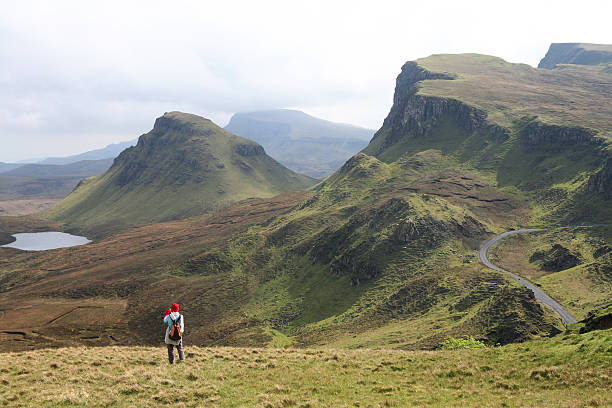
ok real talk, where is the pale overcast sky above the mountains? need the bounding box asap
[0,0,612,162]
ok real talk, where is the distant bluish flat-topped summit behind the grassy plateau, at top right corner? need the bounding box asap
[538,43,612,69]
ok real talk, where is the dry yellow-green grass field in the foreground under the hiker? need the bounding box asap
[0,330,612,407]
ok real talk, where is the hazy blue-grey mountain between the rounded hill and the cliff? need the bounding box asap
[225,109,374,178]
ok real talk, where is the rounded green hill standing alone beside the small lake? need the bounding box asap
[48,112,315,233]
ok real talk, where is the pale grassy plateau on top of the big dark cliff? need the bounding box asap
[416,54,612,132]
